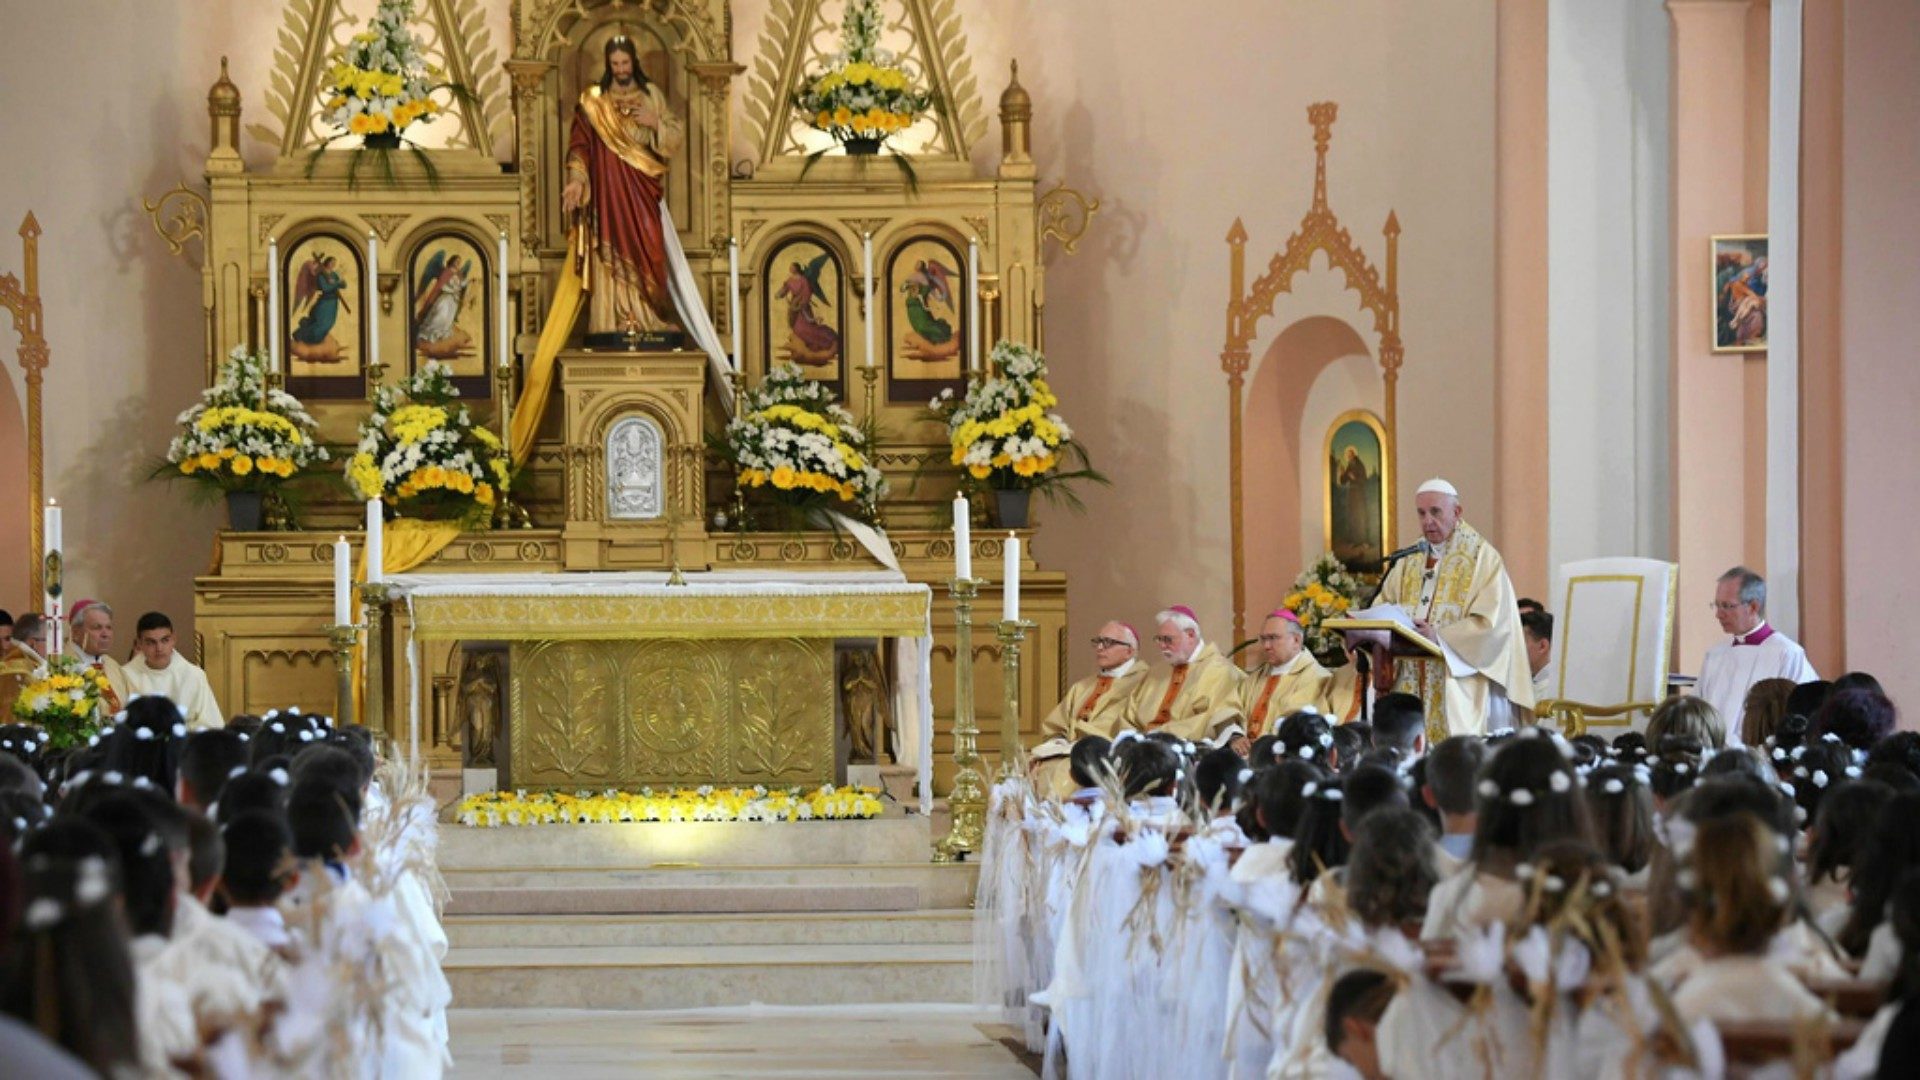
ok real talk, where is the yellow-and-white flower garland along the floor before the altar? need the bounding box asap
[455,784,885,828]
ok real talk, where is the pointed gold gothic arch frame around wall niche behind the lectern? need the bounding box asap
[1219,102,1405,642]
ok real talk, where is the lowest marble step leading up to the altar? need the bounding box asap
[442,945,973,1009]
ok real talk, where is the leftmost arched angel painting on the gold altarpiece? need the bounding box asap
[275,233,367,402]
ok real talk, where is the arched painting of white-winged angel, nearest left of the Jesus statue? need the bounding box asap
[407,231,499,398]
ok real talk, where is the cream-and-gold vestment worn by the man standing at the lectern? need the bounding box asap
[1380,521,1534,742]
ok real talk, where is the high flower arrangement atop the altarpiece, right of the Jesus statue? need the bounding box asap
[793,0,933,163]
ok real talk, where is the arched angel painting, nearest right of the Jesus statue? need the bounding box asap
[760,236,847,402]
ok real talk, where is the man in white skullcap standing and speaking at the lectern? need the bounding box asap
[1379,479,1534,730]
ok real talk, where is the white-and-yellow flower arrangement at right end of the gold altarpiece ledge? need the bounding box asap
[931,340,1108,528]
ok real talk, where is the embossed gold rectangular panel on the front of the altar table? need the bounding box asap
[509,638,837,788]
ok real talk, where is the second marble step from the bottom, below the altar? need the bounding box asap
[445,911,973,949]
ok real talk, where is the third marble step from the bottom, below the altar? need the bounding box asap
[442,863,979,903]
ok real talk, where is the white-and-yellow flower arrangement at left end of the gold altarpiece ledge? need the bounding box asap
[156,346,328,530]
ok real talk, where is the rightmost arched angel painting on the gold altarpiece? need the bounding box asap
[883,236,972,404]
